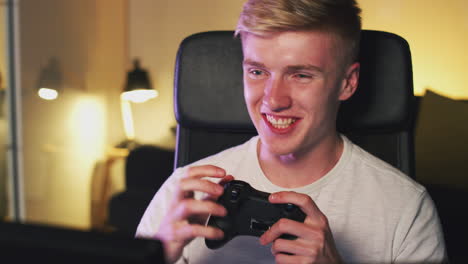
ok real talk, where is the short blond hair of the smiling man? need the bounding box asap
[235,0,361,64]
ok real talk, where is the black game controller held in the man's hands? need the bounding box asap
[205,180,306,249]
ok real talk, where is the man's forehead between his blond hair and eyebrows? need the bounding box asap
[242,31,337,68]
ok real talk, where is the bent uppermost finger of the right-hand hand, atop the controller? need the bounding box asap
[268,191,323,218]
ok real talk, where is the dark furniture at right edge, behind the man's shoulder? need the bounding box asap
[414,90,468,263]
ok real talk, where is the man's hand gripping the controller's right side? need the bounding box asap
[260,192,341,263]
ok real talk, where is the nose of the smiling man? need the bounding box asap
[262,75,292,112]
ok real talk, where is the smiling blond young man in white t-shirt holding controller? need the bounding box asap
[137,0,445,263]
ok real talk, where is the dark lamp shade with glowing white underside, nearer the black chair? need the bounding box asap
[121,60,158,103]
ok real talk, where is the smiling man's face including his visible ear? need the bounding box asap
[242,32,359,159]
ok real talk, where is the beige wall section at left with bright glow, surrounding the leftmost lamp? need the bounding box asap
[19,0,128,228]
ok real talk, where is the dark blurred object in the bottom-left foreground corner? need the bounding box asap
[0,221,165,264]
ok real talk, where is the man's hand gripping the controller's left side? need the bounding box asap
[156,165,233,263]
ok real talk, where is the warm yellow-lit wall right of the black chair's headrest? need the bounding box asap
[358,0,468,99]
